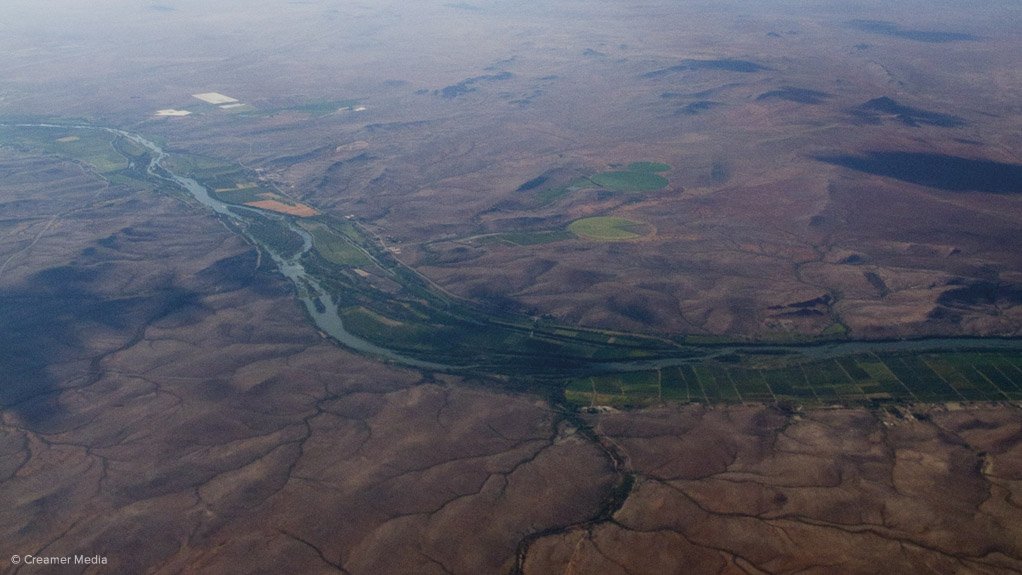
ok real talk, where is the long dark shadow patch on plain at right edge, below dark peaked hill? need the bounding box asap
[815,151,1022,194]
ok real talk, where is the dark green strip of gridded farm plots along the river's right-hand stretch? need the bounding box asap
[565,351,1022,406]
